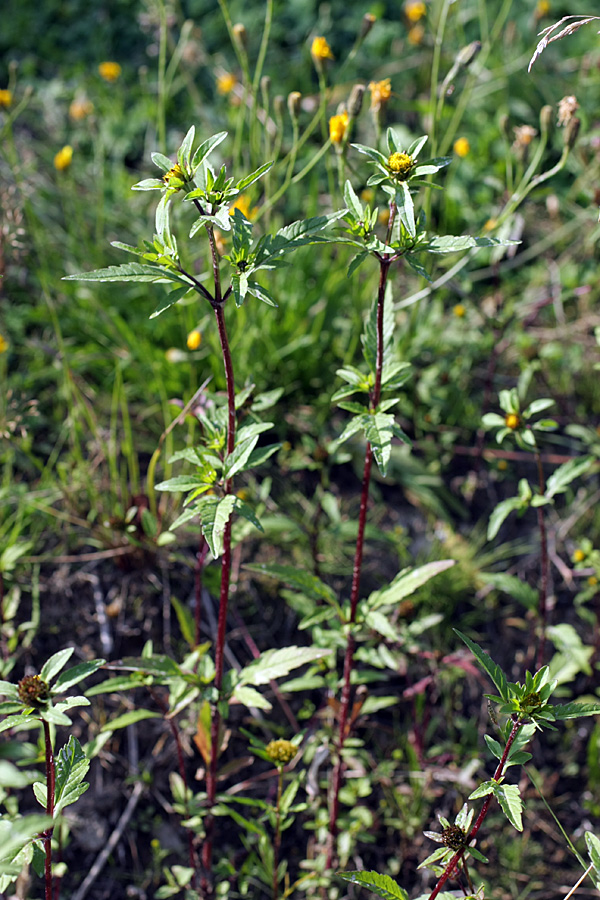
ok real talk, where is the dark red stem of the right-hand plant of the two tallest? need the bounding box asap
[325,258,390,869]
